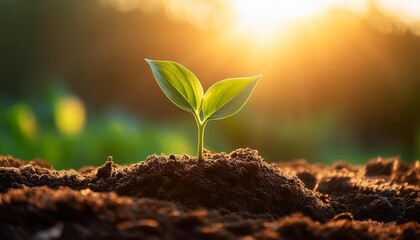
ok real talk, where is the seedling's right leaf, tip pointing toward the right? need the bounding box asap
[202,75,262,120]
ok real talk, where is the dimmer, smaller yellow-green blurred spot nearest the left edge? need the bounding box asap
[16,104,37,139]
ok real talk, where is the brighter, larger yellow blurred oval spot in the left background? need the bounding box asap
[54,97,86,137]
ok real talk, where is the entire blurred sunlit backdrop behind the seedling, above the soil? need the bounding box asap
[0,0,420,169]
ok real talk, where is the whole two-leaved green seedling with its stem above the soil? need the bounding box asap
[146,59,262,160]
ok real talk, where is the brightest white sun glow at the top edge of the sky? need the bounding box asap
[232,0,366,44]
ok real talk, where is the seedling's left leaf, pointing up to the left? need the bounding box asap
[145,59,204,112]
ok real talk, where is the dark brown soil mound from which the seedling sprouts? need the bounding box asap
[101,149,334,221]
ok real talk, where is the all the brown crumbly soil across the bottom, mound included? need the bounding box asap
[0,149,420,240]
